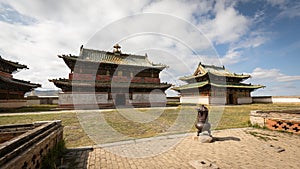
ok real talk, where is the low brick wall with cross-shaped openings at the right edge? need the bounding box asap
[250,110,300,134]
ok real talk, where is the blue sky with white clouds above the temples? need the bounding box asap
[0,0,300,96]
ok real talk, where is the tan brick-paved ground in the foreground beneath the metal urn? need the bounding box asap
[64,128,300,169]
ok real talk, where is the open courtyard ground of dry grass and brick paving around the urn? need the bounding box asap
[0,103,300,168]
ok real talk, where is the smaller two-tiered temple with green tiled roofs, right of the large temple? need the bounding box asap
[172,62,264,104]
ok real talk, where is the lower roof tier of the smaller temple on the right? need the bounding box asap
[172,81,265,91]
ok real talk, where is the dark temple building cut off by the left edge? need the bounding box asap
[0,56,41,107]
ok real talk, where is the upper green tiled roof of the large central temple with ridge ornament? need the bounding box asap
[58,45,167,70]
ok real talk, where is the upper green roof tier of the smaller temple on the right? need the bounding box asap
[179,62,251,81]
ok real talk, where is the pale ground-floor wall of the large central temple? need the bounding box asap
[58,91,167,109]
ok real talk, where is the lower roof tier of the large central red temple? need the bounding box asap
[49,79,171,90]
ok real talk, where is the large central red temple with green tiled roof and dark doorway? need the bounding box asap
[49,44,171,108]
